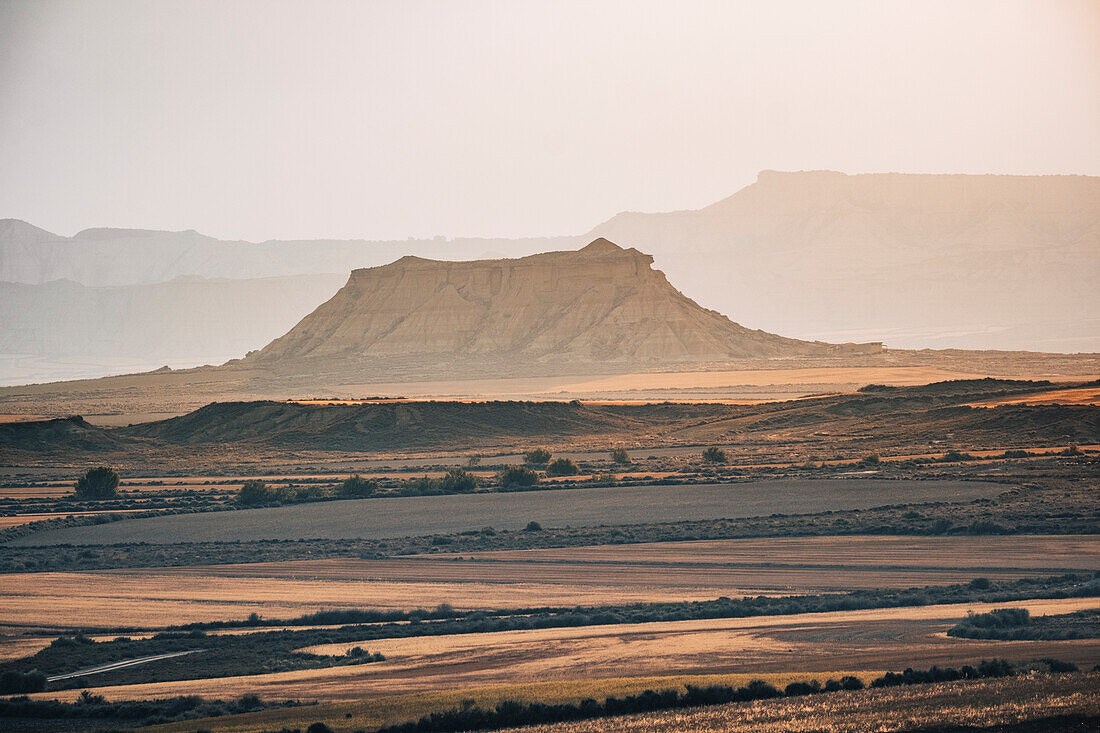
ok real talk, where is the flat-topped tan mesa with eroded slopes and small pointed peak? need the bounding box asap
[249,238,875,368]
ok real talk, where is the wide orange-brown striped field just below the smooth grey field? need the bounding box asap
[0,535,1086,627]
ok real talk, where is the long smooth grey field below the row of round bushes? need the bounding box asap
[11,479,1005,546]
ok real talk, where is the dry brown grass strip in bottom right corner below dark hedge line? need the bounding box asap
[497,674,1100,733]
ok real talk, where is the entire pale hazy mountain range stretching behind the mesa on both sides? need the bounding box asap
[0,172,1100,384]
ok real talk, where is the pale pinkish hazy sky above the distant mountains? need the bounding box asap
[0,0,1100,240]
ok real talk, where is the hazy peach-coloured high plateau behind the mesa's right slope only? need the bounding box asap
[590,171,1100,352]
